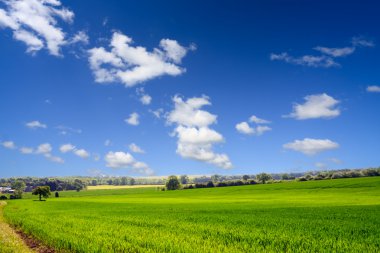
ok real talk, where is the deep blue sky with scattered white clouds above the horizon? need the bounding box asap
[0,0,380,177]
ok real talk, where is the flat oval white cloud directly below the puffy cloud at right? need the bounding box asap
[283,138,339,155]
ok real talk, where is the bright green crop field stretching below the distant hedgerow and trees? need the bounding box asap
[5,177,380,252]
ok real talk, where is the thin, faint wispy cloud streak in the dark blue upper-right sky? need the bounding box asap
[270,37,375,68]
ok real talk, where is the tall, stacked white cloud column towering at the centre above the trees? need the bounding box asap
[167,96,232,169]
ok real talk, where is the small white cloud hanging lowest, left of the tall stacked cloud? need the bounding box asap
[104,151,154,175]
